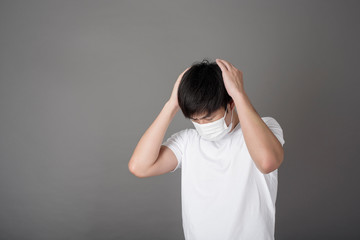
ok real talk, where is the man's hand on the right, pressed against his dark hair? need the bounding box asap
[216,58,245,98]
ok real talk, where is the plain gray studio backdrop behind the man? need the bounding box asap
[0,0,360,240]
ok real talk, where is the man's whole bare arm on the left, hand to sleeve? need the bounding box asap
[128,68,189,178]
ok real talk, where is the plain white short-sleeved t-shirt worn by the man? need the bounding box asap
[163,117,285,240]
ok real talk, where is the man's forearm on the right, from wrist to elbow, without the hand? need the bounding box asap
[233,92,283,173]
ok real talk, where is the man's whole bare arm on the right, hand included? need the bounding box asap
[216,59,284,174]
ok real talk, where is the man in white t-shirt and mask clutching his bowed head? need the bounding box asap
[129,59,285,240]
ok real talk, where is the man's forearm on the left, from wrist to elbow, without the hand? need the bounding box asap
[128,101,179,172]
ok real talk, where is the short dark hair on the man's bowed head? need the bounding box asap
[178,58,232,118]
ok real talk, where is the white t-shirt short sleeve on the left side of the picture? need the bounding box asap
[162,129,188,172]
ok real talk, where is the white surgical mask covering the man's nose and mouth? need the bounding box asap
[191,107,234,141]
